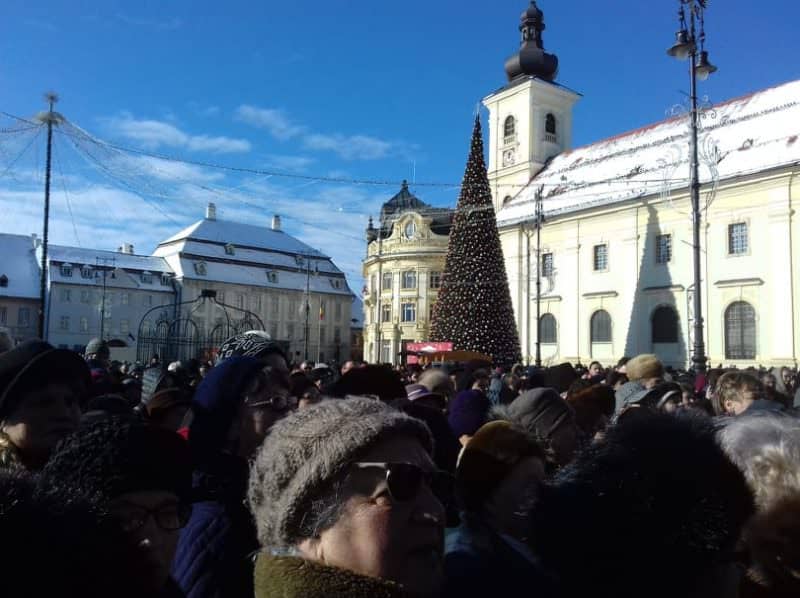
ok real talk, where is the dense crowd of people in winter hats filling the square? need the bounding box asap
[0,331,800,598]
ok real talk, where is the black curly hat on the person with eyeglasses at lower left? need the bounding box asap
[43,416,192,504]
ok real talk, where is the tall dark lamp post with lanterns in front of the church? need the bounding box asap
[667,0,717,373]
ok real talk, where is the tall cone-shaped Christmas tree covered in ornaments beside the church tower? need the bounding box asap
[431,117,520,367]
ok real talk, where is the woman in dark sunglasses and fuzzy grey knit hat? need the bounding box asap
[248,397,448,598]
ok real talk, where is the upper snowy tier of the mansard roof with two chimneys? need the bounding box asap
[156,219,326,257]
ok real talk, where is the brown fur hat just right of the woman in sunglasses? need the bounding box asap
[456,420,545,511]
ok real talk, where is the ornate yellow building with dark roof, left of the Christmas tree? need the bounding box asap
[363,181,453,364]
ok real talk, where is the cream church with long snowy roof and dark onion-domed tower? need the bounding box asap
[484,2,800,367]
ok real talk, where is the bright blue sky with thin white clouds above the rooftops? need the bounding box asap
[0,0,800,288]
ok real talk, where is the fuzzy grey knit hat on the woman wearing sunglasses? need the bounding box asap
[247,397,433,548]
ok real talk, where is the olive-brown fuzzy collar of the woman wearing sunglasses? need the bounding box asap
[255,553,406,598]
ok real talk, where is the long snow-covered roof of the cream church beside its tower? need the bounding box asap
[497,81,800,227]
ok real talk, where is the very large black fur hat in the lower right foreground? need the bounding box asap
[532,409,754,598]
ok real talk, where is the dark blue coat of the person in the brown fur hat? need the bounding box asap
[442,515,555,598]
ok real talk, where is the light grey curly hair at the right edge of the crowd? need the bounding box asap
[719,414,800,510]
